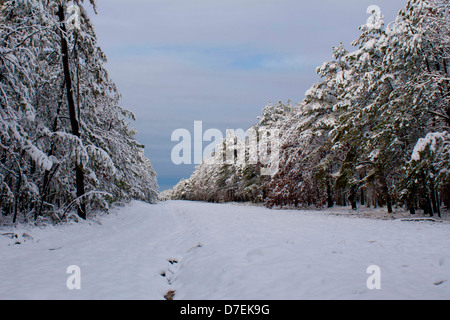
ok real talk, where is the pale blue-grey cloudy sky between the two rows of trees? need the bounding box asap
[86,0,406,190]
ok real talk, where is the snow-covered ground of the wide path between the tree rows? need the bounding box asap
[0,201,450,300]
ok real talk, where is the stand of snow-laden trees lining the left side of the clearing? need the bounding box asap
[0,0,157,221]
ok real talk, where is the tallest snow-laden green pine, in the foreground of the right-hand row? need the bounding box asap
[318,1,448,212]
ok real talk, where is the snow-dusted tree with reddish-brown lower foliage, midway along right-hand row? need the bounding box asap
[265,46,347,207]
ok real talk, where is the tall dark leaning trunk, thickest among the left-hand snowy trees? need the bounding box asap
[58,4,86,219]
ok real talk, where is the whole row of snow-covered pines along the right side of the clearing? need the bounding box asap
[167,0,450,215]
